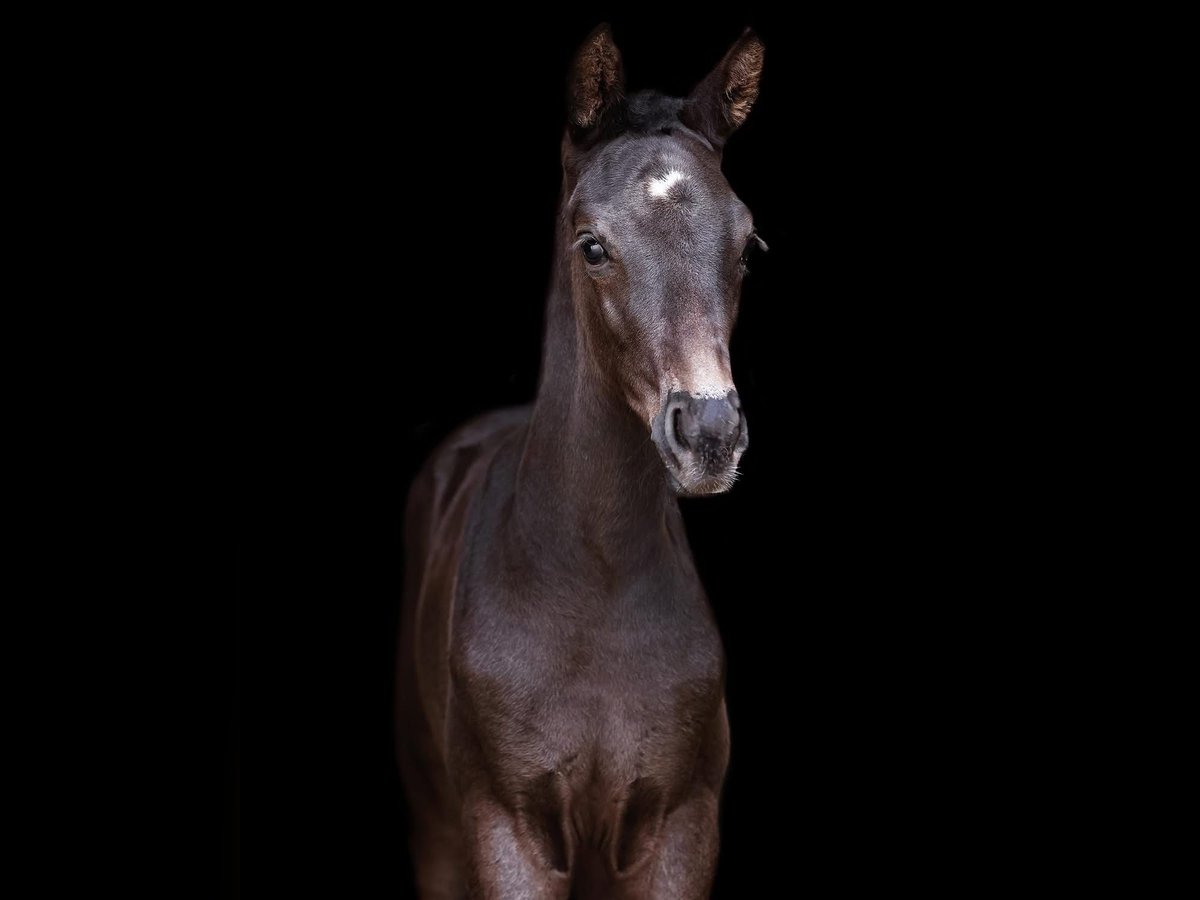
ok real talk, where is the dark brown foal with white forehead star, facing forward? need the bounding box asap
[397,26,763,900]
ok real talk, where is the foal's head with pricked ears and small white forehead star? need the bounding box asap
[564,31,764,494]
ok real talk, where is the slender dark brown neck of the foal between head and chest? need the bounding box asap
[514,192,679,570]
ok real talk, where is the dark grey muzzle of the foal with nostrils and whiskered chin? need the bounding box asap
[650,391,749,494]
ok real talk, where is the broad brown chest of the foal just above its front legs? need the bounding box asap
[454,592,722,780]
